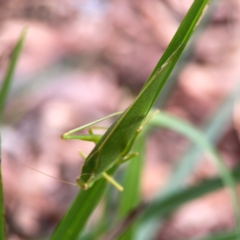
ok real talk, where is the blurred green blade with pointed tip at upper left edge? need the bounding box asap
[0,29,26,122]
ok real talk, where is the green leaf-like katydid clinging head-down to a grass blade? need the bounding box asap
[62,43,185,191]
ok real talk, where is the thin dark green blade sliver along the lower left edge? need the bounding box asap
[0,136,6,240]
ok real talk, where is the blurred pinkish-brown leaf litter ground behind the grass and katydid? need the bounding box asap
[0,0,240,240]
